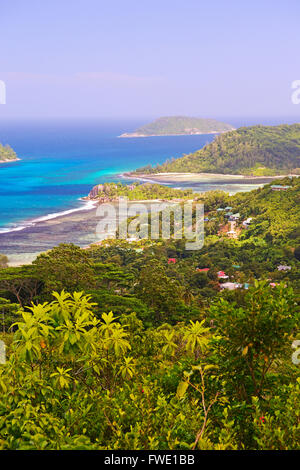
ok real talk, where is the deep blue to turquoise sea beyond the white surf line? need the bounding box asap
[0,121,217,232]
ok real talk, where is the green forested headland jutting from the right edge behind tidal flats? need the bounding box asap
[135,124,300,176]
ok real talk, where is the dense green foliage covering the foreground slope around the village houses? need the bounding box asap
[0,178,300,450]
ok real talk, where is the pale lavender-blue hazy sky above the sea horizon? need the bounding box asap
[0,0,300,121]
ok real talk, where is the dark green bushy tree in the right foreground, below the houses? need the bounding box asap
[210,281,299,403]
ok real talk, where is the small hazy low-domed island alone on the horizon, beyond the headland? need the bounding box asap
[119,116,234,137]
